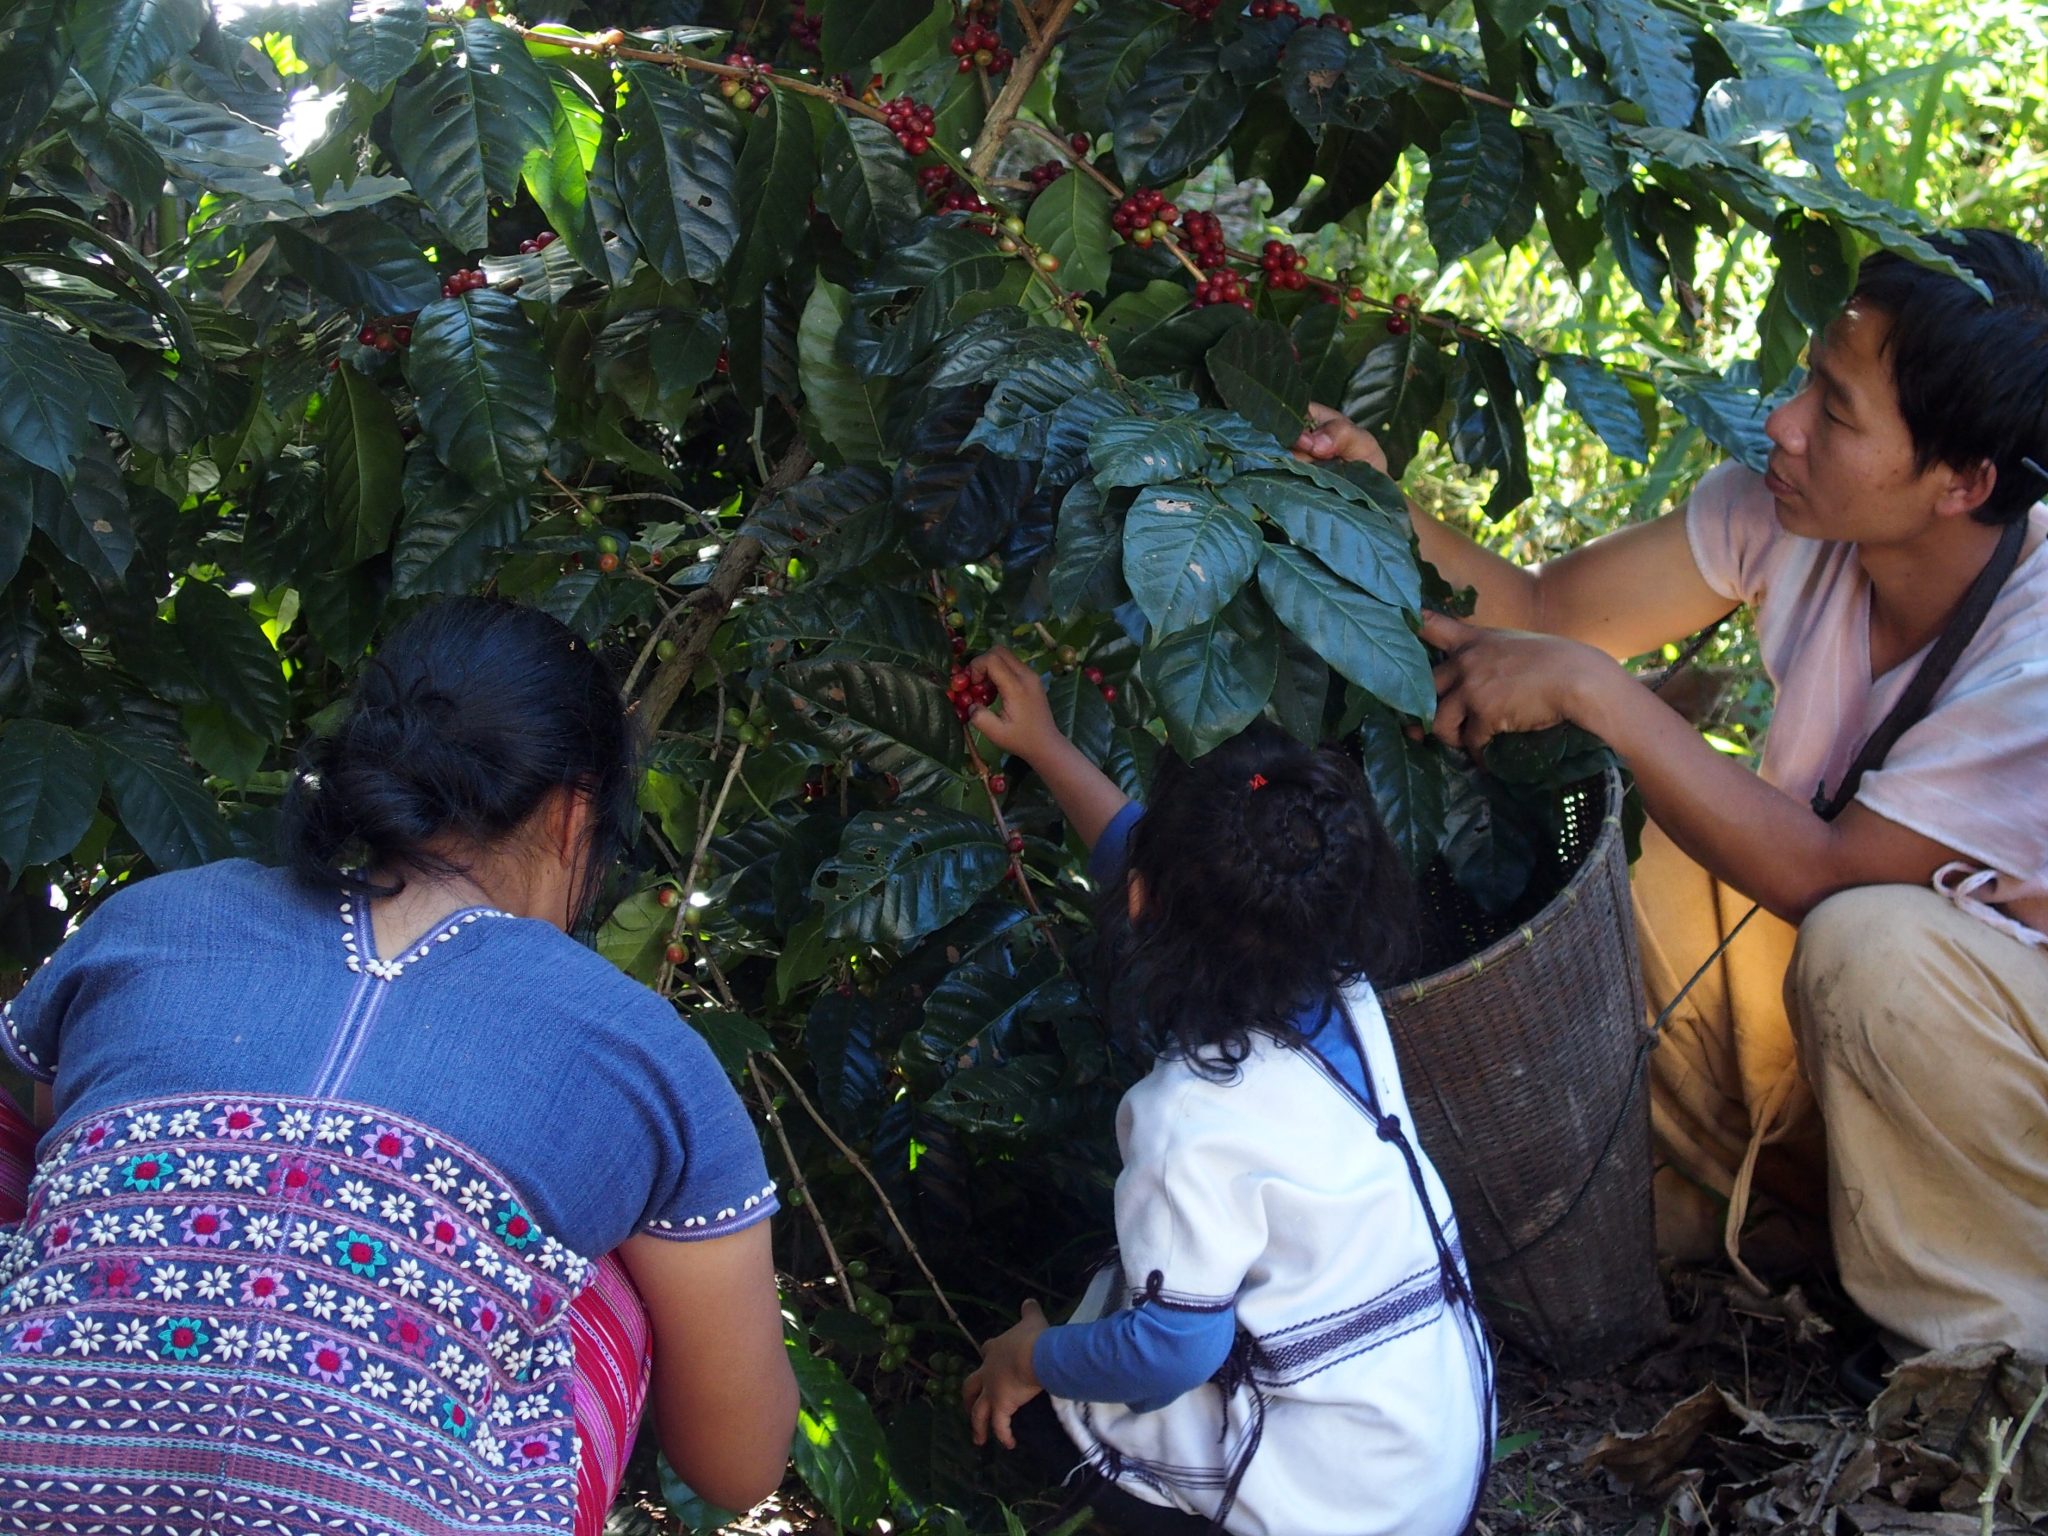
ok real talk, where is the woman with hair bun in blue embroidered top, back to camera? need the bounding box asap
[0,598,797,1536]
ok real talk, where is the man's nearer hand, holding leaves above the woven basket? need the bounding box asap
[1421,612,1628,758]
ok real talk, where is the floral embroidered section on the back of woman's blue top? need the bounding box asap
[0,1098,590,1530]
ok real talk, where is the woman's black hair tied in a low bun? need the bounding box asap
[285,598,639,913]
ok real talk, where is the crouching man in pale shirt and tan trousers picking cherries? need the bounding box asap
[1296,229,2048,1354]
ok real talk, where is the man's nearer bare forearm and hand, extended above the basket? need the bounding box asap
[1421,614,1960,924]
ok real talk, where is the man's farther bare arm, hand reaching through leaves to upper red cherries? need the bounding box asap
[1294,406,1735,657]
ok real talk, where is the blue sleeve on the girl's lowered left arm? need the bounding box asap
[1030,1307,1237,1413]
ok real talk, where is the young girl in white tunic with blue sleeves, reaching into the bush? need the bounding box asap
[967,651,1493,1536]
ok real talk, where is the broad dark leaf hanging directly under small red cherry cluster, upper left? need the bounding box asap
[406,289,555,494]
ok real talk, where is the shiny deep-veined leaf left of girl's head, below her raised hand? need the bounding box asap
[811,807,1010,948]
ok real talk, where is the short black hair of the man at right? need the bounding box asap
[1855,229,2048,524]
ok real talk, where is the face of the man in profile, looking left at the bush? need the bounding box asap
[1763,301,1954,545]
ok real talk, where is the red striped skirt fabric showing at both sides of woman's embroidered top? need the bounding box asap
[0,1092,651,1536]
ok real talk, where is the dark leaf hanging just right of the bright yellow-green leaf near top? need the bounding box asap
[618,63,739,283]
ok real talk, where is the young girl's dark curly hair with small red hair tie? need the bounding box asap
[1098,721,1413,1075]
